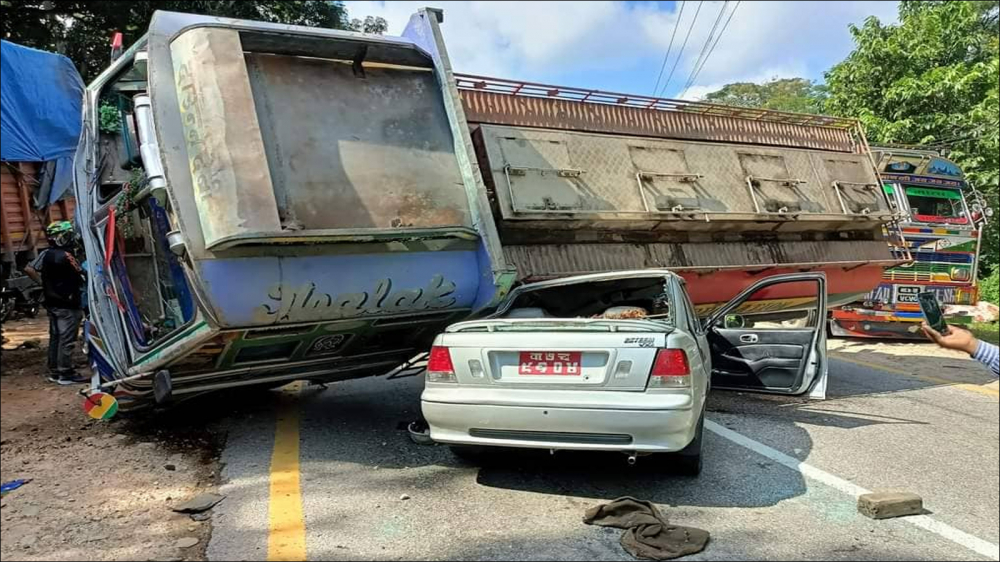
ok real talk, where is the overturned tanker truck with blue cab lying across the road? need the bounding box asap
[76,9,907,406]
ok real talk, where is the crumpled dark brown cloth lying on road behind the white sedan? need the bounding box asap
[583,497,709,560]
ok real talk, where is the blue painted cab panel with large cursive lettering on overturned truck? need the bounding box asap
[198,251,484,328]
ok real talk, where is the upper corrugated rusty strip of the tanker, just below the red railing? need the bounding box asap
[461,89,859,153]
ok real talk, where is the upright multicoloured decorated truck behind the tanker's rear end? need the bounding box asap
[831,147,992,339]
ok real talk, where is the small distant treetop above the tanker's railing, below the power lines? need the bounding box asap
[705,78,826,113]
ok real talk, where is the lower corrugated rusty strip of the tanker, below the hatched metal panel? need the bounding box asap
[504,240,898,279]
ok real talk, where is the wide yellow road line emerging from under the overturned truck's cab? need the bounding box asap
[267,383,306,560]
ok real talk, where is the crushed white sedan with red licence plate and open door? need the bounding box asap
[421,270,826,474]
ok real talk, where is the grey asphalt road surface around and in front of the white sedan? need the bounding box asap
[208,344,1000,560]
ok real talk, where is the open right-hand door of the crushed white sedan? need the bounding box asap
[705,273,827,399]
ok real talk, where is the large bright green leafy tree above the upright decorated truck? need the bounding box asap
[826,0,1000,268]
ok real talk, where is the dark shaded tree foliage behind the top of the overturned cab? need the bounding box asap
[0,0,386,81]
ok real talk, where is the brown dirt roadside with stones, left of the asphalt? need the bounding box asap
[0,317,221,560]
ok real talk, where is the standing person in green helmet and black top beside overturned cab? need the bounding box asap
[24,221,88,385]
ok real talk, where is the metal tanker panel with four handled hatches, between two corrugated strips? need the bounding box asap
[479,124,892,231]
